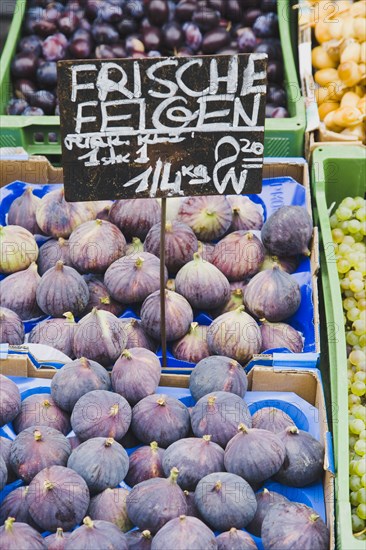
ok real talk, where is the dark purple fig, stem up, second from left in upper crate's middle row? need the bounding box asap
[36,261,89,317]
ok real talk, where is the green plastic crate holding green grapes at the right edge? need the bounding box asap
[312,145,366,550]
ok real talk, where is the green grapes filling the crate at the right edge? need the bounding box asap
[330,197,366,540]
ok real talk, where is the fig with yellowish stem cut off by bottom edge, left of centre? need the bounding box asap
[65,517,128,550]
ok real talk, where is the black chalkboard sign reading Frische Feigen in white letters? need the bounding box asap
[58,53,266,201]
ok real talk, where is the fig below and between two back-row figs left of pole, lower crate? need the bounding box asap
[71,390,131,440]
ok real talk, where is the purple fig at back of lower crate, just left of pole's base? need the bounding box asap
[112,348,161,405]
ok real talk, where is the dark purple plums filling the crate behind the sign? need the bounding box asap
[7,0,288,118]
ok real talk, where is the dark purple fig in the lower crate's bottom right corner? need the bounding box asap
[262,502,329,550]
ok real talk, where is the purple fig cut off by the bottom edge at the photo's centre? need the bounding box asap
[151,516,217,550]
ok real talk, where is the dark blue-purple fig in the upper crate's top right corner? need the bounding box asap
[262,206,313,256]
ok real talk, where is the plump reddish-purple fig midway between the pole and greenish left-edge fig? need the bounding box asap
[69,220,126,273]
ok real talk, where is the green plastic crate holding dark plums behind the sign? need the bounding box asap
[0,0,305,157]
